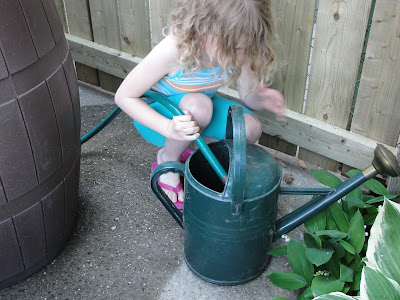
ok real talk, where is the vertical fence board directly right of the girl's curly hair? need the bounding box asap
[260,0,316,155]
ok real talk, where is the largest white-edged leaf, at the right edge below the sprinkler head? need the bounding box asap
[366,200,400,284]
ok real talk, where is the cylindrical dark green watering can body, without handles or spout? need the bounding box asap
[183,140,281,285]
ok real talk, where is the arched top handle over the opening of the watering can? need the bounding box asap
[224,105,246,215]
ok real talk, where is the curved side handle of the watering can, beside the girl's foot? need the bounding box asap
[150,161,185,228]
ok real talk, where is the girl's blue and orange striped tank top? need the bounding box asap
[151,67,227,97]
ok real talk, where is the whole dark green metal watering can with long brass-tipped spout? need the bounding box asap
[151,94,400,285]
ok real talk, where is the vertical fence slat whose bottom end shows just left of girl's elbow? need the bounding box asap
[89,0,121,92]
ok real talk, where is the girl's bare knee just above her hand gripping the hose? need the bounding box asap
[179,93,213,128]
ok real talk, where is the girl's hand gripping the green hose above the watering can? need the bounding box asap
[166,110,200,141]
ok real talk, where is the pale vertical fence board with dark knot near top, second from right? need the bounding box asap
[299,0,371,170]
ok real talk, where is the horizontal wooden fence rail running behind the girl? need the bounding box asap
[66,34,397,168]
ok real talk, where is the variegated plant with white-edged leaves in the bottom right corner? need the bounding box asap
[315,200,400,300]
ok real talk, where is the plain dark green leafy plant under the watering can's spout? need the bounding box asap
[267,170,396,299]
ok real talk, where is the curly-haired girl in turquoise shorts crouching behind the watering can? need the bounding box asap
[115,0,284,208]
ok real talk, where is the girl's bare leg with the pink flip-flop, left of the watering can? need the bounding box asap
[157,94,213,202]
